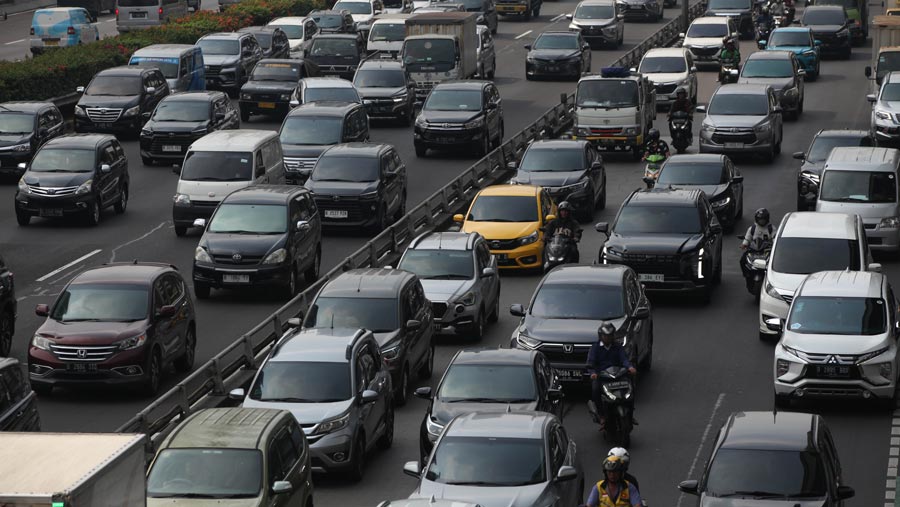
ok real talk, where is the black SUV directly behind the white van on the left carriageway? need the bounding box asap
[141,91,241,165]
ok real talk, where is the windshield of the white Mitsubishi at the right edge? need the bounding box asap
[787,296,887,336]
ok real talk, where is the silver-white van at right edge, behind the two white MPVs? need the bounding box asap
[816,147,900,252]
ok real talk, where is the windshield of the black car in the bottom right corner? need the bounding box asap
[706,449,826,498]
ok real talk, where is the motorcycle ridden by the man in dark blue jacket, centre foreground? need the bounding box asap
[588,366,634,447]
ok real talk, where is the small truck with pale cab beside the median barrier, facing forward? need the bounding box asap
[572,67,656,158]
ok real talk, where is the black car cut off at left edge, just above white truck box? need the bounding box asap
[0,360,41,431]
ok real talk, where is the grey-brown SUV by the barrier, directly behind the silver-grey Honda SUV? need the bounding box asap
[303,268,434,405]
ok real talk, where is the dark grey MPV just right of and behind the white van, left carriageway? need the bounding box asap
[278,101,369,185]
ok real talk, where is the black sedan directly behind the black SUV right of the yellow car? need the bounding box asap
[657,153,744,231]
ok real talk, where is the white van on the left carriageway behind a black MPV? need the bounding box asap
[172,130,285,236]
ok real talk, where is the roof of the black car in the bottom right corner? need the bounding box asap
[719,411,819,451]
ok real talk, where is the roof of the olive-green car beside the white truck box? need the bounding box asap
[163,407,290,449]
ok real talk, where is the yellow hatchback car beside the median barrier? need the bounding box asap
[453,185,556,269]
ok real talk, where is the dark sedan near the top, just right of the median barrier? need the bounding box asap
[525,32,591,79]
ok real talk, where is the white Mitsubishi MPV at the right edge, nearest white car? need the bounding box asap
[773,271,898,406]
